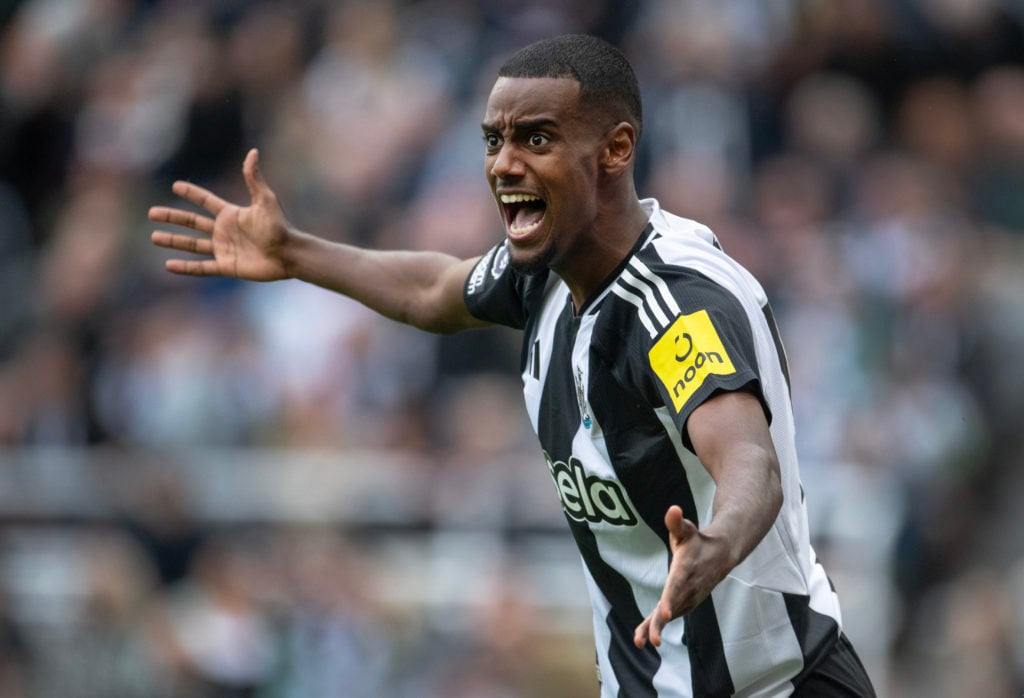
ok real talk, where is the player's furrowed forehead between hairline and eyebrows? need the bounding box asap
[483,78,580,128]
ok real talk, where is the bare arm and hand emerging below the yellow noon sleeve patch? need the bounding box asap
[633,392,782,648]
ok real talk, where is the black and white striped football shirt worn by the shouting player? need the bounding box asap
[464,200,841,698]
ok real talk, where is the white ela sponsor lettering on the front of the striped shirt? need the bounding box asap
[544,451,637,526]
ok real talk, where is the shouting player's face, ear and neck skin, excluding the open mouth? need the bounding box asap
[481,78,647,308]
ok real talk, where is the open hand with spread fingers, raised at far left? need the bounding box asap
[150,148,290,281]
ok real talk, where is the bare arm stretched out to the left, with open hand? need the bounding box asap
[150,148,484,333]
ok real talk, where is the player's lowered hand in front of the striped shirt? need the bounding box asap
[633,506,732,649]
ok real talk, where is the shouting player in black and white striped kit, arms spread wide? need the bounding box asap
[150,35,874,698]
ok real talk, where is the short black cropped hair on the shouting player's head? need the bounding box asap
[498,34,643,137]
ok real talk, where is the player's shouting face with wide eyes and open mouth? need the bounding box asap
[482,78,602,272]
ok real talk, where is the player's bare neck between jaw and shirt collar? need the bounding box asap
[553,192,647,312]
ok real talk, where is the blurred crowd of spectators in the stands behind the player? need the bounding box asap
[0,0,1024,698]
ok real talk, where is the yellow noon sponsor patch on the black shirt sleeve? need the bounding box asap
[647,310,736,412]
